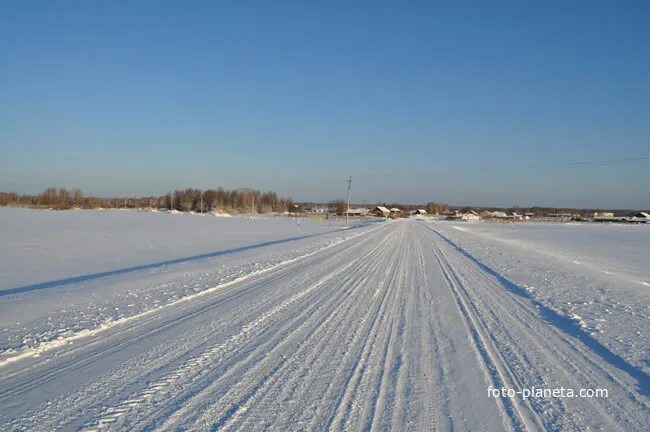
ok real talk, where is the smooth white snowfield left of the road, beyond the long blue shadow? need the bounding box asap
[0,207,354,291]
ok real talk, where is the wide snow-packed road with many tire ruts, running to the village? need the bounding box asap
[0,220,650,431]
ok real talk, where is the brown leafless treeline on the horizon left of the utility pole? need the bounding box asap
[0,188,294,213]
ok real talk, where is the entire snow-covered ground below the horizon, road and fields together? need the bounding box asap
[0,209,650,431]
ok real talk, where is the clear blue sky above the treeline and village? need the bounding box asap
[0,0,650,208]
